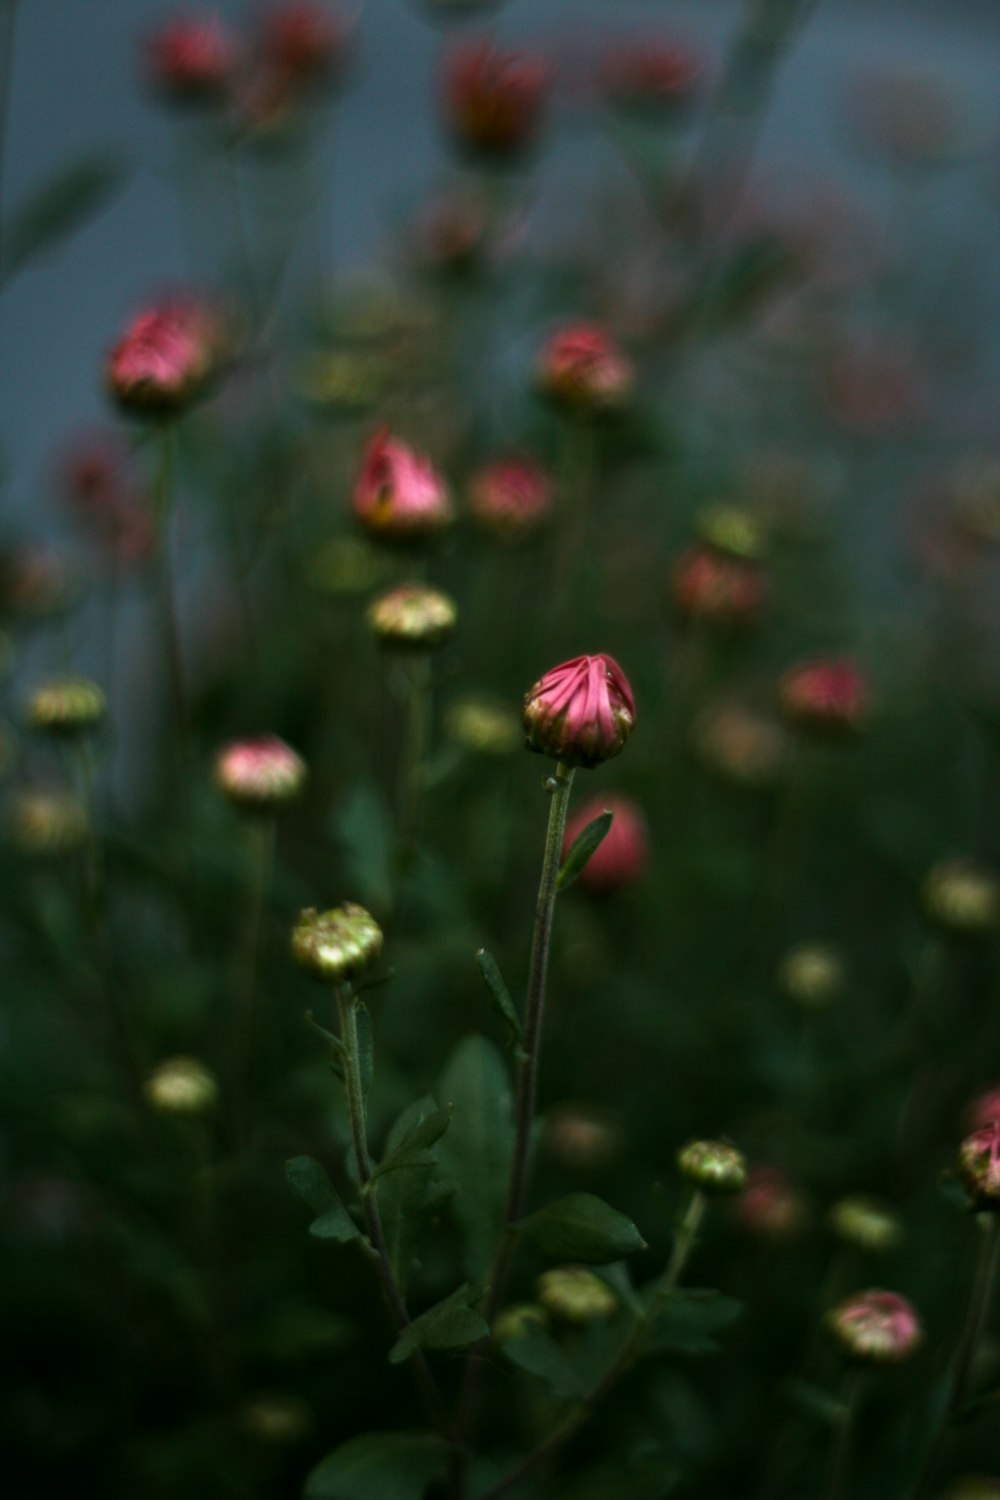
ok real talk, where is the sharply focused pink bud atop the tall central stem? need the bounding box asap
[523,656,636,768]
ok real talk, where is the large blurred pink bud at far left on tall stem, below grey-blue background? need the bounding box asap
[105,297,229,419]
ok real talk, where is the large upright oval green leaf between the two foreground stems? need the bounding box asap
[438,1037,514,1281]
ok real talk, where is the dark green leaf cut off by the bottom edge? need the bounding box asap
[306,1433,448,1500]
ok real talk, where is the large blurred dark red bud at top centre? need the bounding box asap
[444,42,552,161]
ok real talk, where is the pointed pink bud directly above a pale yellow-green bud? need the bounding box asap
[354,428,451,542]
